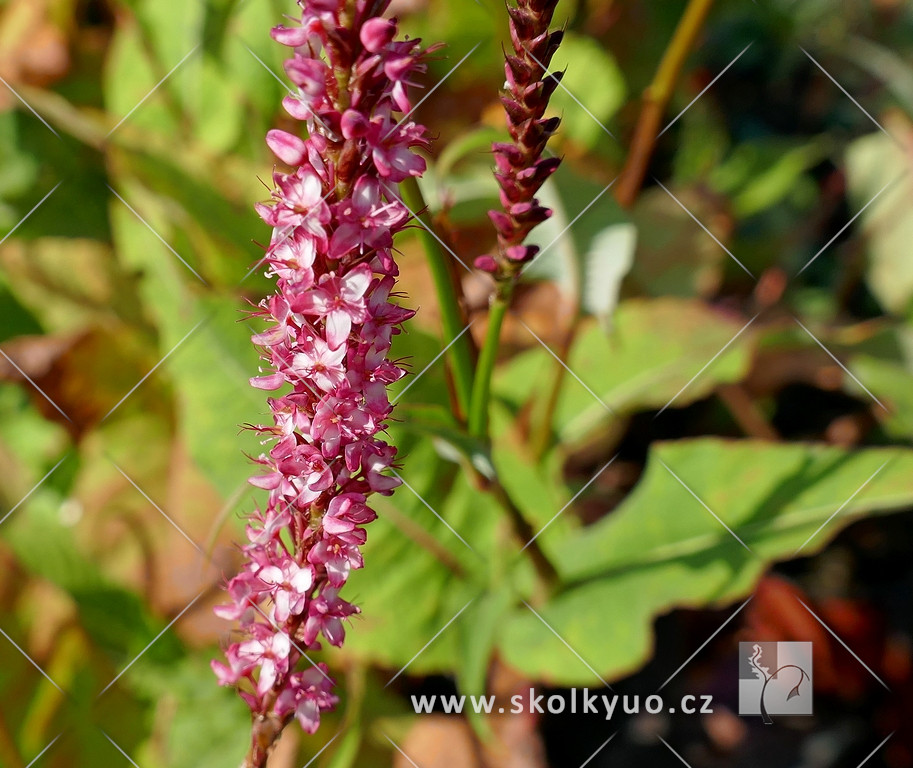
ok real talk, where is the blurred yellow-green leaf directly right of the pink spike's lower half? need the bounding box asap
[346,443,499,674]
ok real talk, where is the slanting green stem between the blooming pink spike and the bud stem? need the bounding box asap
[400,176,475,421]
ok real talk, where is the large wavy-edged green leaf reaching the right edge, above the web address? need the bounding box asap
[500,438,913,685]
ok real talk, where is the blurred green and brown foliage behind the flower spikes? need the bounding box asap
[0,0,913,768]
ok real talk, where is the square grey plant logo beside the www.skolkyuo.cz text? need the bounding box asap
[739,643,812,725]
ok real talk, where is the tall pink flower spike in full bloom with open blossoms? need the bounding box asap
[212,0,438,768]
